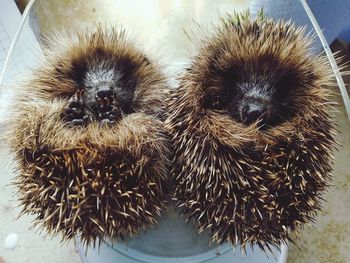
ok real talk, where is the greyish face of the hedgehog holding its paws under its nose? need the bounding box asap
[83,65,134,113]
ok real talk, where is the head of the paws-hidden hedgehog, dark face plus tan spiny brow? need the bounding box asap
[200,22,315,128]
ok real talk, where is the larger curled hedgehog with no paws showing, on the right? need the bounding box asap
[166,13,336,249]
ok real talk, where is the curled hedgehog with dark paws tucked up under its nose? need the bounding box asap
[9,27,169,248]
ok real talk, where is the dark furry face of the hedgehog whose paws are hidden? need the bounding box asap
[205,57,301,127]
